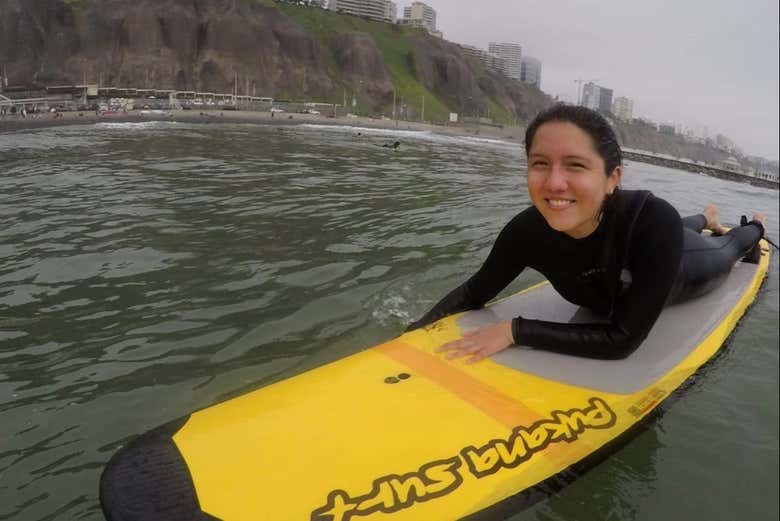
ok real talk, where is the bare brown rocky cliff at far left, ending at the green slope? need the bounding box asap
[0,0,335,95]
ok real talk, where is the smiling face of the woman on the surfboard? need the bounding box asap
[528,121,622,239]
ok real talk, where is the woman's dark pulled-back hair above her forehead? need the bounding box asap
[525,103,623,177]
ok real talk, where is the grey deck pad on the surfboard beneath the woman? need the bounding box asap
[457,262,758,394]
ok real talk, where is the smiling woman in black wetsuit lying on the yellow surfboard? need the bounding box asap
[407,104,764,362]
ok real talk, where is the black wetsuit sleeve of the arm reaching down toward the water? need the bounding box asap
[406,211,533,331]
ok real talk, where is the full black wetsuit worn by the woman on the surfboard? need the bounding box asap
[408,191,763,359]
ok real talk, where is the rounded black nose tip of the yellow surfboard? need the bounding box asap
[100,417,220,521]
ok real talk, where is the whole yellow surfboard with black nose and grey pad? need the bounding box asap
[100,243,769,521]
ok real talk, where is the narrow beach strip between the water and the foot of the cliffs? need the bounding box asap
[0,110,525,144]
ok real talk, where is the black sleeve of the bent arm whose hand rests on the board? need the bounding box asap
[512,198,683,360]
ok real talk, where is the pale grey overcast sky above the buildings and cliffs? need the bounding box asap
[420,0,780,159]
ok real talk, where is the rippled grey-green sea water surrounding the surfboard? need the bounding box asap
[0,123,780,521]
